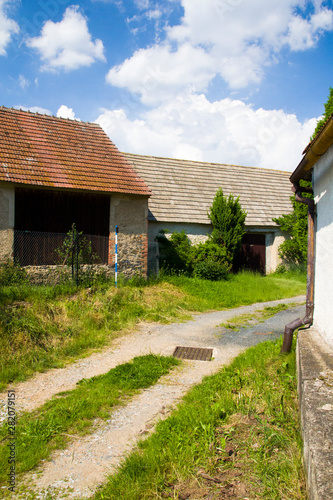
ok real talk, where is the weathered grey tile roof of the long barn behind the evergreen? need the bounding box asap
[123,153,292,226]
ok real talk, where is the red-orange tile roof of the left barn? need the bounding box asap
[0,107,150,196]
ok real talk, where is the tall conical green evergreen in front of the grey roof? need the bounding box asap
[208,188,246,263]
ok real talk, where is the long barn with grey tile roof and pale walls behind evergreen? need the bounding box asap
[124,153,292,273]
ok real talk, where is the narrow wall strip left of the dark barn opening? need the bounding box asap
[0,183,15,260]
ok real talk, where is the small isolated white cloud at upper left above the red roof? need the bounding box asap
[26,6,105,71]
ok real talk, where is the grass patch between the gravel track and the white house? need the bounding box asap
[93,334,306,500]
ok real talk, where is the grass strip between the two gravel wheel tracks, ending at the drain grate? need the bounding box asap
[0,354,180,484]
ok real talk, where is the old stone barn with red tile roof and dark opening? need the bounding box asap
[0,107,150,274]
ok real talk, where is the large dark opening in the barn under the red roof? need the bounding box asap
[14,188,110,265]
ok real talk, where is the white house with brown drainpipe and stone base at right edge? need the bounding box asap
[282,115,333,500]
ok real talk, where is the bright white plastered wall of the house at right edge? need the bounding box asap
[313,146,333,347]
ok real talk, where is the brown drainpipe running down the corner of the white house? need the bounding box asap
[281,183,315,352]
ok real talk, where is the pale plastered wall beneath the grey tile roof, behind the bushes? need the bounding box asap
[148,221,285,274]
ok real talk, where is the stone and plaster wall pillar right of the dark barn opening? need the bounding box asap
[109,194,148,277]
